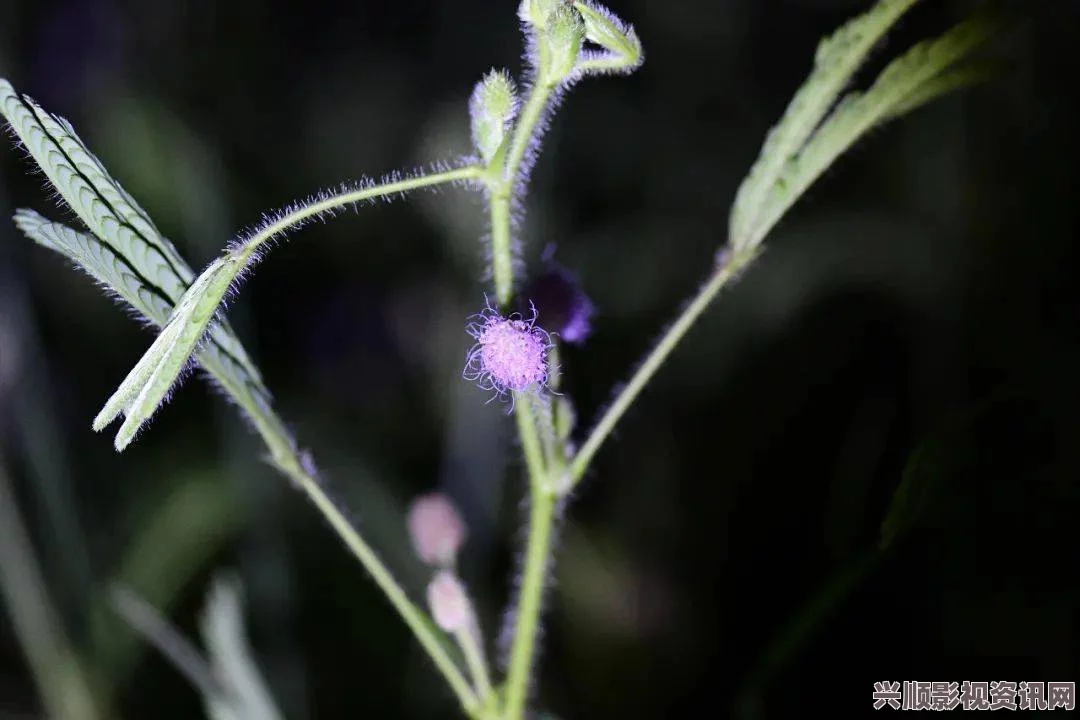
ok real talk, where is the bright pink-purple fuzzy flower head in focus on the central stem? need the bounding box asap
[462,302,554,402]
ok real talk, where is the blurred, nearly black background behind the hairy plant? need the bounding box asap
[0,0,1080,720]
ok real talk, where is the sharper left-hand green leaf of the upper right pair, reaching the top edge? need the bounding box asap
[728,0,918,249]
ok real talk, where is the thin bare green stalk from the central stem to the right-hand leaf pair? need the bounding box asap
[569,248,758,488]
